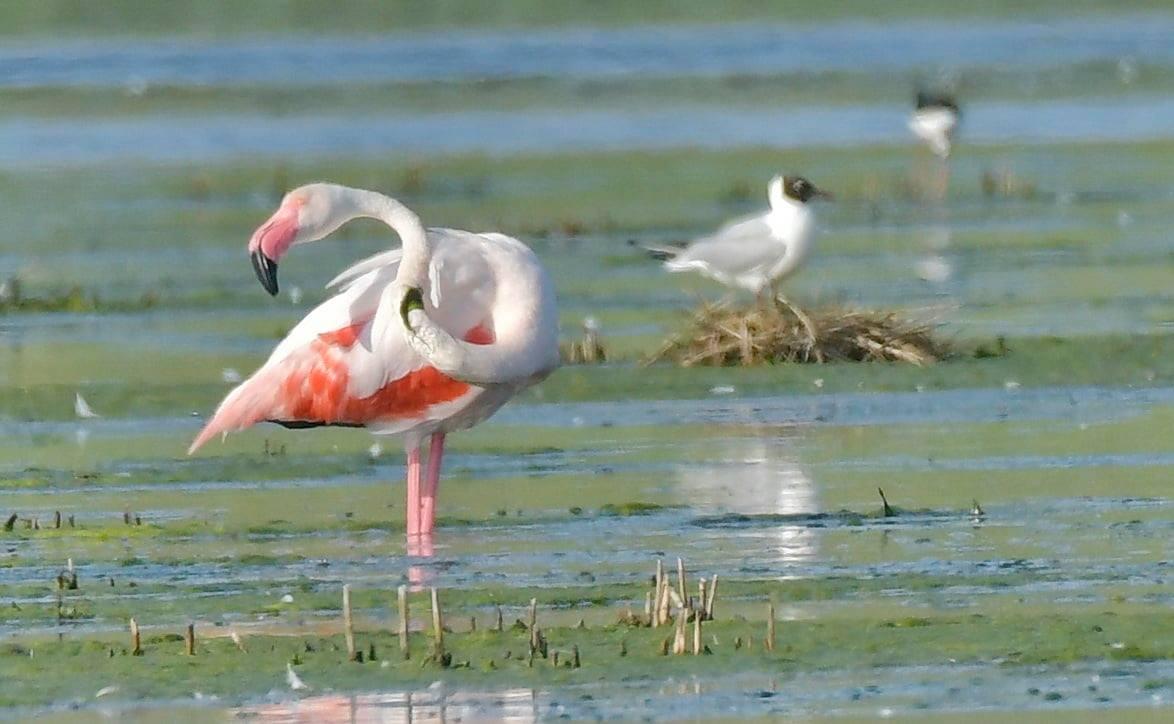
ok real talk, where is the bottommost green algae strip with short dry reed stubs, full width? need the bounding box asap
[0,591,1174,705]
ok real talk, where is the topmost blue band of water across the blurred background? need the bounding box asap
[9,14,1174,87]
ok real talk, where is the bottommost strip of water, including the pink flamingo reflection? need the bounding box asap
[221,664,1172,722]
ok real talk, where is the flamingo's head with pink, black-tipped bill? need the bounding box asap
[249,183,348,296]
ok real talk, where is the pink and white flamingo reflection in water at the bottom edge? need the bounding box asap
[240,684,551,724]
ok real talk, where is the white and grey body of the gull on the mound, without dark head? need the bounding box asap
[664,176,815,295]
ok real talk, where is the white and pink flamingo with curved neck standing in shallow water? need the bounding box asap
[188,183,559,541]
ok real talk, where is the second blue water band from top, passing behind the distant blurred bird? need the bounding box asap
[11,96,1174,168]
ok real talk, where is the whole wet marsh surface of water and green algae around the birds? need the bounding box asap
[0,4,1174,720]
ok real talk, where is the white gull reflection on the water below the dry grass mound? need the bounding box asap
[676,437,819,563]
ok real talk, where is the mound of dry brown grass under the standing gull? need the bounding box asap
[648,302,950,367]
